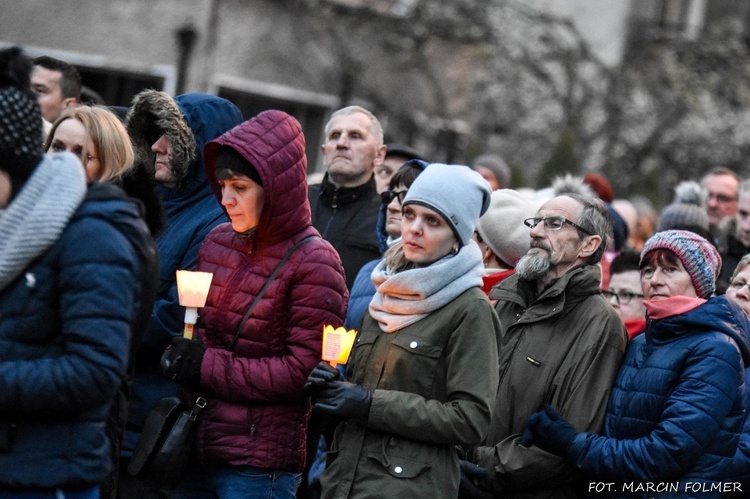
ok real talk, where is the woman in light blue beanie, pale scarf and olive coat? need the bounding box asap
[308,164,500,498]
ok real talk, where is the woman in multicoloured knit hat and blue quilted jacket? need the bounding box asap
[522,230,750,498]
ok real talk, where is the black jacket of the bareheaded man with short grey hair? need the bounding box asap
[308,174,380,290]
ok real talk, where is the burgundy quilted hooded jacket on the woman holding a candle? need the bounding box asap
[196,111,348,471]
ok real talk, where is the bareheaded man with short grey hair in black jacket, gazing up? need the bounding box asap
[308,106,386,290]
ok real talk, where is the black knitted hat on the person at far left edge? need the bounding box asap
[0,47,43,192]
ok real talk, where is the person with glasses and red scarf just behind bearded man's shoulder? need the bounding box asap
[602,249,646,340]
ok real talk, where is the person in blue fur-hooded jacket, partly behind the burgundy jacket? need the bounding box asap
[121,90,242,497]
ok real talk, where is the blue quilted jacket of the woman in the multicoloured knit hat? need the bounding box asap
[569,297,750,498]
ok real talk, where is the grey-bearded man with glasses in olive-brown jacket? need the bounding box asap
[460,194,627,498]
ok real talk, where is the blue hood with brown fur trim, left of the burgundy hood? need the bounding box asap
[125,90,242,194]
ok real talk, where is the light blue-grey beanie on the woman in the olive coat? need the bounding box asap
[403,163,491,246]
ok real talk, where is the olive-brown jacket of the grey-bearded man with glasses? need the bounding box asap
[475,265,627,498]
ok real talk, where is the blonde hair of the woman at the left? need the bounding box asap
[44,106,135,182]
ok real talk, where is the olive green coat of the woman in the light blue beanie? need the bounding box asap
[320,287,500,499]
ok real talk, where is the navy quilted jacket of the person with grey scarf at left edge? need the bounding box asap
[0,184,150,490]
